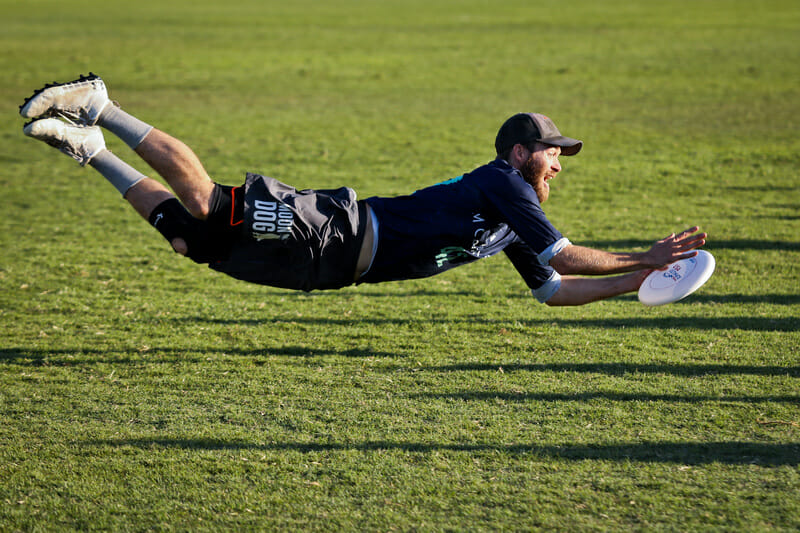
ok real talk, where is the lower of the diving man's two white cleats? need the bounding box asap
[22,118,106,167]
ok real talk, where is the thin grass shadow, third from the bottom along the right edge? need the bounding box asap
[422,363,800,378]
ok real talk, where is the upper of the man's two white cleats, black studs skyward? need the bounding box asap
[19,72,111,126]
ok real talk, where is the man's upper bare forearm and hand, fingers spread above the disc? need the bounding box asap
[550,226,707,274]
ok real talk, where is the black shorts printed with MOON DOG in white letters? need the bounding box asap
[209,173,367,291]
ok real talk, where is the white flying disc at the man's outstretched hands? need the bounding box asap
[639,250,716,306]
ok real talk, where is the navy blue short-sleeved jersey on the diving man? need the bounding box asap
[359,159,569,299]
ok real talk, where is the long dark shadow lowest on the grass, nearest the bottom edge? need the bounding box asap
[83,438,800,466]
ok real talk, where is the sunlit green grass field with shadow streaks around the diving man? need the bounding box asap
[0,0,800,531]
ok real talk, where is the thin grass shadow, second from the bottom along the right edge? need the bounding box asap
[408,391,800,405]
